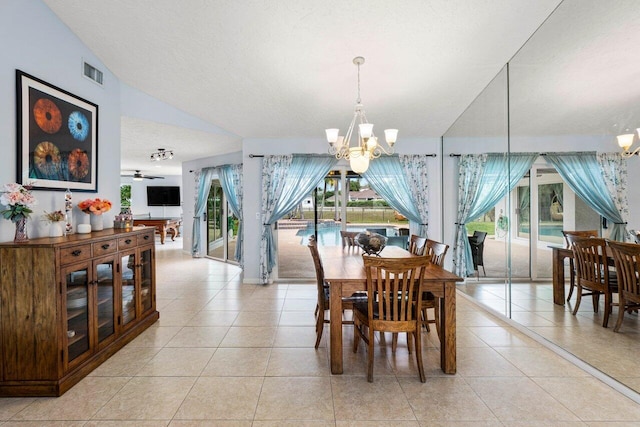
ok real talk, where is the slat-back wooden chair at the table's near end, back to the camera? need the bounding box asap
[353,255,429,382]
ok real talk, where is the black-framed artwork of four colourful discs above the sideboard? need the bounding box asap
[16,70,98,191]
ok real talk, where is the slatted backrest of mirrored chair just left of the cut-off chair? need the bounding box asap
[573,237,609,288]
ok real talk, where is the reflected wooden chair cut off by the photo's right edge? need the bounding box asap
[607,241,640,332]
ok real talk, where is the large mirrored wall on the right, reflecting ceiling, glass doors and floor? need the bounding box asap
[442,0,640,391]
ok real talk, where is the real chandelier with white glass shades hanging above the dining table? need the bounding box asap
[325,56,398,173]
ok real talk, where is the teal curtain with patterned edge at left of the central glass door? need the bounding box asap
[259,154,337,284]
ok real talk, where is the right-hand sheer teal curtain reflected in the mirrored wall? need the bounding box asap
[545,152,626,241]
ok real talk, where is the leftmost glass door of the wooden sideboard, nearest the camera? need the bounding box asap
[63,264,91,362]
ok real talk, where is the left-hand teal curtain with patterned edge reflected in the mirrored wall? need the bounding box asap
[453,153,538,276]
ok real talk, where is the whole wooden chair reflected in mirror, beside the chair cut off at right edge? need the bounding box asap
[573,237,618,328]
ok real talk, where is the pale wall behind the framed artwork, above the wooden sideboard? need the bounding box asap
[0,0,120,241]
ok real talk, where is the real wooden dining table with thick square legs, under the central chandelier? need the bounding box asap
[318,246,463,374]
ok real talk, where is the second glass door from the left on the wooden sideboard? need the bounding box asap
[93,258,116,343]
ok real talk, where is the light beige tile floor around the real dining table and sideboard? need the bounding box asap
[0,239,640,427]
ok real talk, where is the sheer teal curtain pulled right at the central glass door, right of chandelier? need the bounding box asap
[362,156,428,235]
